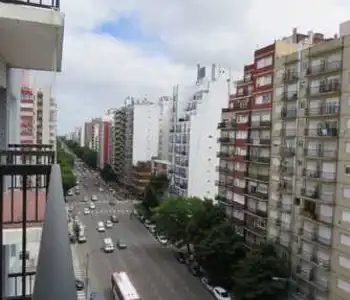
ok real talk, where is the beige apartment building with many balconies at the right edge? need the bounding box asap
[268,23,350,300]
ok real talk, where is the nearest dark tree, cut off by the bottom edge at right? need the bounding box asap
[234,244,288,300]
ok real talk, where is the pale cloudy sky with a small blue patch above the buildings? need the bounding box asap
[55,0,350,133]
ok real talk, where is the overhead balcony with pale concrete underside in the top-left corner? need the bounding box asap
[0,0,64,72]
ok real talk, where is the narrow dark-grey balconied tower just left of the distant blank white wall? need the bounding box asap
[112,107,126,178]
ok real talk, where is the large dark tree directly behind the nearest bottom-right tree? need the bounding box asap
[194,221,245,288]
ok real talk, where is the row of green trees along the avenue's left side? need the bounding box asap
[57,140,77,195]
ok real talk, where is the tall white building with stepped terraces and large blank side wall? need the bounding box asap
[169,65,229,200]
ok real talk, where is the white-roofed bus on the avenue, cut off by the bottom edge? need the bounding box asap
[111,272,141,300]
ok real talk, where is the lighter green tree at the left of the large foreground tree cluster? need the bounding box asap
[153,197,202,252]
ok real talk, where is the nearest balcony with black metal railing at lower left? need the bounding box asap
[0,145,77,300]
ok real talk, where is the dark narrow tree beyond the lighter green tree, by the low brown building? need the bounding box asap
[142,174,169,214]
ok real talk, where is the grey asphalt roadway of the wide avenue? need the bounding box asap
[66,164,213,300]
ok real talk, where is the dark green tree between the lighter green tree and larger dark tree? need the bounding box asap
[188,199,226,244]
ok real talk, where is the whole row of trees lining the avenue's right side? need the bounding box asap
[141,176,288,300]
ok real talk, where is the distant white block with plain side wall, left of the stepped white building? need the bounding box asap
[123,97,160,185]
